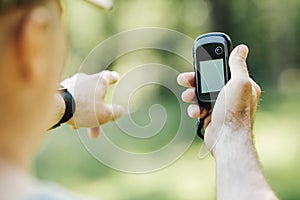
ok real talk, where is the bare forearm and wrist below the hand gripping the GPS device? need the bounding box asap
[213,128,277,200]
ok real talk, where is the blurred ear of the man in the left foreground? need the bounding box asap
[17,6,52,82]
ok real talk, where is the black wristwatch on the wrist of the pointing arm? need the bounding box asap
[51,87,76,129]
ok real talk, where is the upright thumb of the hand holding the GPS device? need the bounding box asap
[229,45,249,79]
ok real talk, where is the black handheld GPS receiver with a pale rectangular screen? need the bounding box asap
[193,32,232,108]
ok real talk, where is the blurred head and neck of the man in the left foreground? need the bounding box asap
[0,0,66,168]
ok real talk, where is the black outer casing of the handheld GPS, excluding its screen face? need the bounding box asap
[193,32,232,108]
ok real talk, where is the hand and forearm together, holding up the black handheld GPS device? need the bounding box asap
[178,45,277,200]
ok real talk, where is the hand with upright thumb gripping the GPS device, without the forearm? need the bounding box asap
[178,45,261,151]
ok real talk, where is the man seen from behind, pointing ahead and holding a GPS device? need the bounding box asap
[0,0,276,200]
